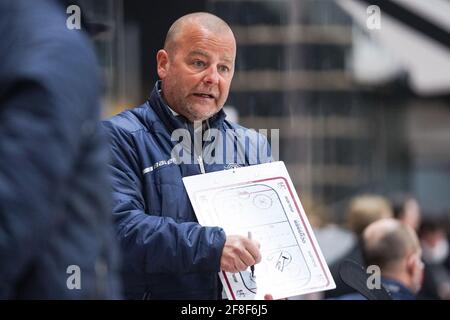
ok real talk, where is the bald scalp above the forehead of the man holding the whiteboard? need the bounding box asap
[164,12,234,53]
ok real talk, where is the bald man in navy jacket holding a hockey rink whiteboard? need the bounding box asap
[104,13,271,299]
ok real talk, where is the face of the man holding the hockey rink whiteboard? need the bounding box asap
[157,26,236,122]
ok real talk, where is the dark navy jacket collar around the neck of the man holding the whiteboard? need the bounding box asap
[148,80,226,133]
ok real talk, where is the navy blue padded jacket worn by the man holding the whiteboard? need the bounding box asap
[104,83,270,299]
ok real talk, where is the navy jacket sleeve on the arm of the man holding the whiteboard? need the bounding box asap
[103,121,226,273]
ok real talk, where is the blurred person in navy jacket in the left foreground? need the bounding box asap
[0,0,119,299]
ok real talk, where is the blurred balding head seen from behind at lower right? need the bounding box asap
[363,218,420,272]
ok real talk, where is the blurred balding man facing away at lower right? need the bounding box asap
[341,218,423,300]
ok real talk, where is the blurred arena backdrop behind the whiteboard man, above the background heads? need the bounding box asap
[75,0,450,223]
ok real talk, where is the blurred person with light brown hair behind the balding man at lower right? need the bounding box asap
[325,194,392,298]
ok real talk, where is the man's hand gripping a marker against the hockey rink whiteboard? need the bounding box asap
[220,235,261,273]
